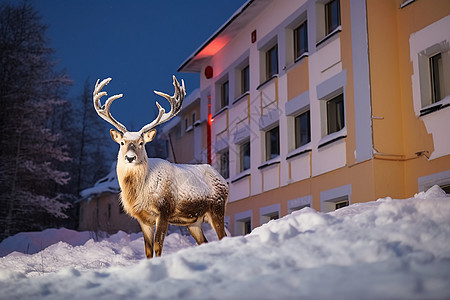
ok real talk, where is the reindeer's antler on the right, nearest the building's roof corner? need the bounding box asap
[139,76,186,134]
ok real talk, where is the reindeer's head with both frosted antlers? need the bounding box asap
[93,76,186,165]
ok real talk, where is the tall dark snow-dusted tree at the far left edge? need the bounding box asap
[0,2,71,240]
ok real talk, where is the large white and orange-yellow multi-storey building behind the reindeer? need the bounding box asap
[179,0,450,235]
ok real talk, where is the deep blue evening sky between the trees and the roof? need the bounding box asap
[31,0,246,131]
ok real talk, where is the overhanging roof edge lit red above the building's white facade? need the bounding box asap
[178,0,272,73]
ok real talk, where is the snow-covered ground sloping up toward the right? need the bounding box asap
[0,186,450,299]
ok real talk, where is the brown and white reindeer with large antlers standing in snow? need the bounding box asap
[93,76,228,258]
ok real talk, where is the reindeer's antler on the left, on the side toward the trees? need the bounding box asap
[92,78,128,133]
